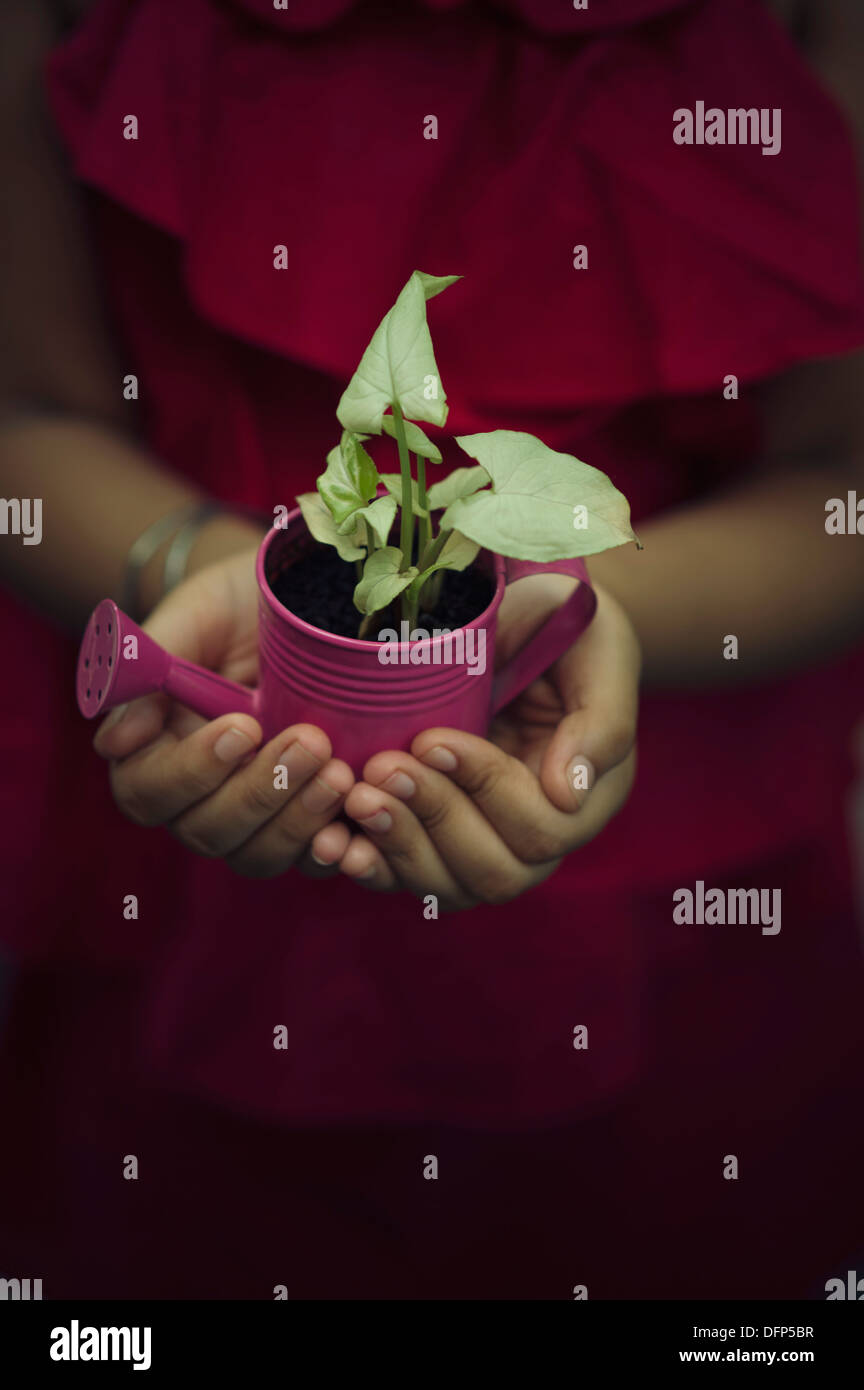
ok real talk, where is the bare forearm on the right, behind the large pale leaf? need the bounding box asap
[589,471,864,687]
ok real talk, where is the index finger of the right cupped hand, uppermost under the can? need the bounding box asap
[400,728,579,867]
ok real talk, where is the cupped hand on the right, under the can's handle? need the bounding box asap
[313,577,640,910]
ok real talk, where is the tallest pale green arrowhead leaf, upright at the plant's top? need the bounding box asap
[336,270,460,434]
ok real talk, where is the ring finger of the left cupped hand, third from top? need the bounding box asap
[225,759,354,878]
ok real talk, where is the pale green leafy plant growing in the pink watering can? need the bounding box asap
[297,271,639,637]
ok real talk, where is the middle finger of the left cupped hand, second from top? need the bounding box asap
[171,724,334,856]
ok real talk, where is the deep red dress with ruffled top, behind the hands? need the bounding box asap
[0,0,864,1298]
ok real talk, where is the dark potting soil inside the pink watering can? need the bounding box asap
[271,546,495,641]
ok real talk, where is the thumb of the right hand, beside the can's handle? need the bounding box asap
[540,594,640,810]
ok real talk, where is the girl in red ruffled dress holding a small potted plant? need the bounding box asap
[0,0,864,1298]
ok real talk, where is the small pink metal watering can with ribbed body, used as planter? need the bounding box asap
[76,507,596,776]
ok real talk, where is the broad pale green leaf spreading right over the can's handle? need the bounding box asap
[440,430,636,562]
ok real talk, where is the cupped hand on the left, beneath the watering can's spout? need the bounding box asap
[93,550,354,878]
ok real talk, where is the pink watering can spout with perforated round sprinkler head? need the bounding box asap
[75,599,257,719]
